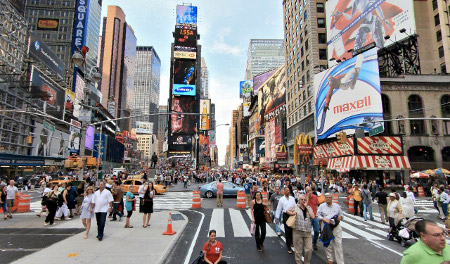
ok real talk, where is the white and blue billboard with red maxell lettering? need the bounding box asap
[314,48,383,139]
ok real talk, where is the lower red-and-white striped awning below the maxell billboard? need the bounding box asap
[328,156,411,170]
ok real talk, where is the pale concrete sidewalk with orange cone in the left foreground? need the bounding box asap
[13,211,188,264]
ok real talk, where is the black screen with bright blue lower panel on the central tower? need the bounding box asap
[172,60,196,96]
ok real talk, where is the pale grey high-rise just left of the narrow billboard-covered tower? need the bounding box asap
[132,46,161,132]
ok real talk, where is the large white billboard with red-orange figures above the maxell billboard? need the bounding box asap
[326,0,416,66]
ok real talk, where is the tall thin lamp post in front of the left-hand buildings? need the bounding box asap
[71,51,102,181]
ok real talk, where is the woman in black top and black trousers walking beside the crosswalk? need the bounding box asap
[251,191,267,252]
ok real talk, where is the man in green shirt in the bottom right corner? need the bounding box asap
[400,220,450,264]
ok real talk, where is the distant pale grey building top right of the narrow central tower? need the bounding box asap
[245,39,285,80]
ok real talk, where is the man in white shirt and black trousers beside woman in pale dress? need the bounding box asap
[91,182,114,241]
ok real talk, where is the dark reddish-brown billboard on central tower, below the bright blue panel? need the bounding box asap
[170,97,195,134]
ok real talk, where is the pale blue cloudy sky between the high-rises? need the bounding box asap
[102,0,284,165]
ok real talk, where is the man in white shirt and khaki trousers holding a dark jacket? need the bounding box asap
[317,193,344,264]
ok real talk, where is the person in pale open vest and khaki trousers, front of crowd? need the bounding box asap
[286,194,315,264]
